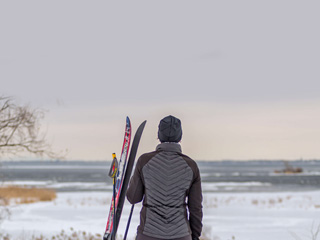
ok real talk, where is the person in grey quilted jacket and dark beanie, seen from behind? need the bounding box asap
[127,115,203,240]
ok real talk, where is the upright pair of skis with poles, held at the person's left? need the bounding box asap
[103,117,147,240]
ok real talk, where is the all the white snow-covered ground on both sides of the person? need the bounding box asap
[0,191,320,240]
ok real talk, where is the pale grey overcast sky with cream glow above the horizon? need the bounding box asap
[0,0,320,160]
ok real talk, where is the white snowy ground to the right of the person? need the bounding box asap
[203,191,320,240]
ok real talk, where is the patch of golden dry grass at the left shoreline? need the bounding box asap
[0,186,57,204]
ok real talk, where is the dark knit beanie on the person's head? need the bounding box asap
[158,115,182,142]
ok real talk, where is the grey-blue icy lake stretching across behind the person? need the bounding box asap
[0,161,320,192]
